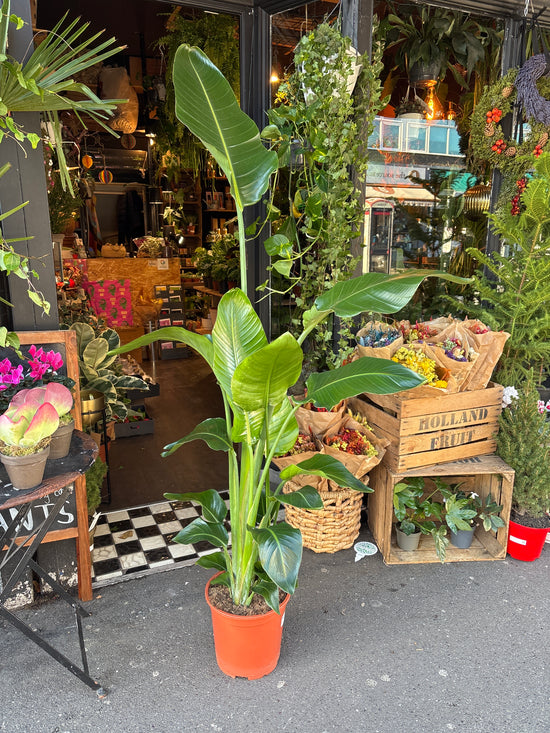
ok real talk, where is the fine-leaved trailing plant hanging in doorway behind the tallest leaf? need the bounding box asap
[155,6,240,177]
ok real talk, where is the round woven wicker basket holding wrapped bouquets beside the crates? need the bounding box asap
[283,481,366,552]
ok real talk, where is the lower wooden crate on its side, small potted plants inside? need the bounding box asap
[368,456,514,565]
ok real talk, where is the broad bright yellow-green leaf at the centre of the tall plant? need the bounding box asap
[231,333,303,411]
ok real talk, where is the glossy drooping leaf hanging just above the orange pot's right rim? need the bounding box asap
[249,522,302,594]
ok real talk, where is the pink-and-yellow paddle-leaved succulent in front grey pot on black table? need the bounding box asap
[0,385,61,491]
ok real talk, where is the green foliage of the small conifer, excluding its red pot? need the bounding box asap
[497,372,550,526]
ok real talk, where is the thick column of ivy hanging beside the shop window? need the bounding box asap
[262,22,385,368]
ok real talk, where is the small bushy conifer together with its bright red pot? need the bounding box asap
[497,372,550,561]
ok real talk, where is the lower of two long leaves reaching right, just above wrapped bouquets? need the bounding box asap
[306,356,426,410]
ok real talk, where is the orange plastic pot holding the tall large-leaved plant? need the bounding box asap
[205,573,290,680]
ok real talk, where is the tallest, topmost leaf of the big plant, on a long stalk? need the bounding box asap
[173,44,278,210]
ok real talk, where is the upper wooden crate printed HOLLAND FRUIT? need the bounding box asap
[362,384,504,471]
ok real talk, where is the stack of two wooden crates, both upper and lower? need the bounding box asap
[356,384,514,565]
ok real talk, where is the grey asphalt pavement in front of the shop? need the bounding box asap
[0,530,550,733]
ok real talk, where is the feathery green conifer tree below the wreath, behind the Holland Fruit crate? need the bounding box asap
[464,153,550,384]
